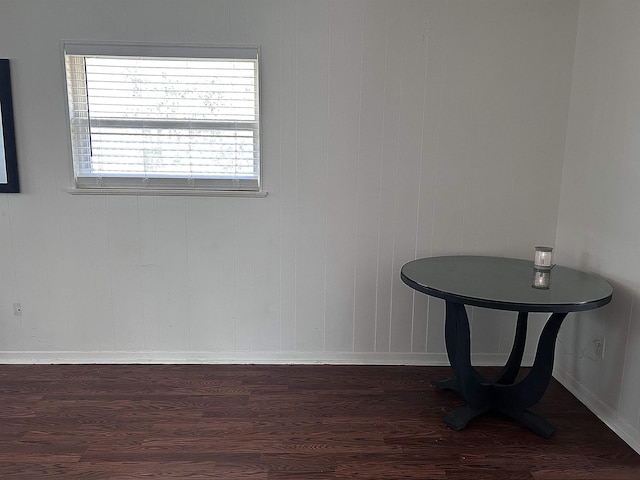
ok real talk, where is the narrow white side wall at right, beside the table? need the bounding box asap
[555,0,640,452]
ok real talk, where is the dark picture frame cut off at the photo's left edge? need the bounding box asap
[0,59,20,193]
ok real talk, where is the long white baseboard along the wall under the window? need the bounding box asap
[0,351,533,366]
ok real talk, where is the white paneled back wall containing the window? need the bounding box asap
[0,0,578,363]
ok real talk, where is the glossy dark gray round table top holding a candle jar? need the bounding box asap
[401,255,613,313]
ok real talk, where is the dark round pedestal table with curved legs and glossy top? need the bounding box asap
[400,256,613,438]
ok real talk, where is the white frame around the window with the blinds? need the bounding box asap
[63,42,266,197]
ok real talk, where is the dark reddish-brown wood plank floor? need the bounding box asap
[0,365,640,480]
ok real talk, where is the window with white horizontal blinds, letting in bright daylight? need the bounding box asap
[64,44,261,193]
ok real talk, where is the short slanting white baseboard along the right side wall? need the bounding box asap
[553,367,640,454]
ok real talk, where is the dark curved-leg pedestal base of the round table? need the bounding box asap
[436,301,567,438]
